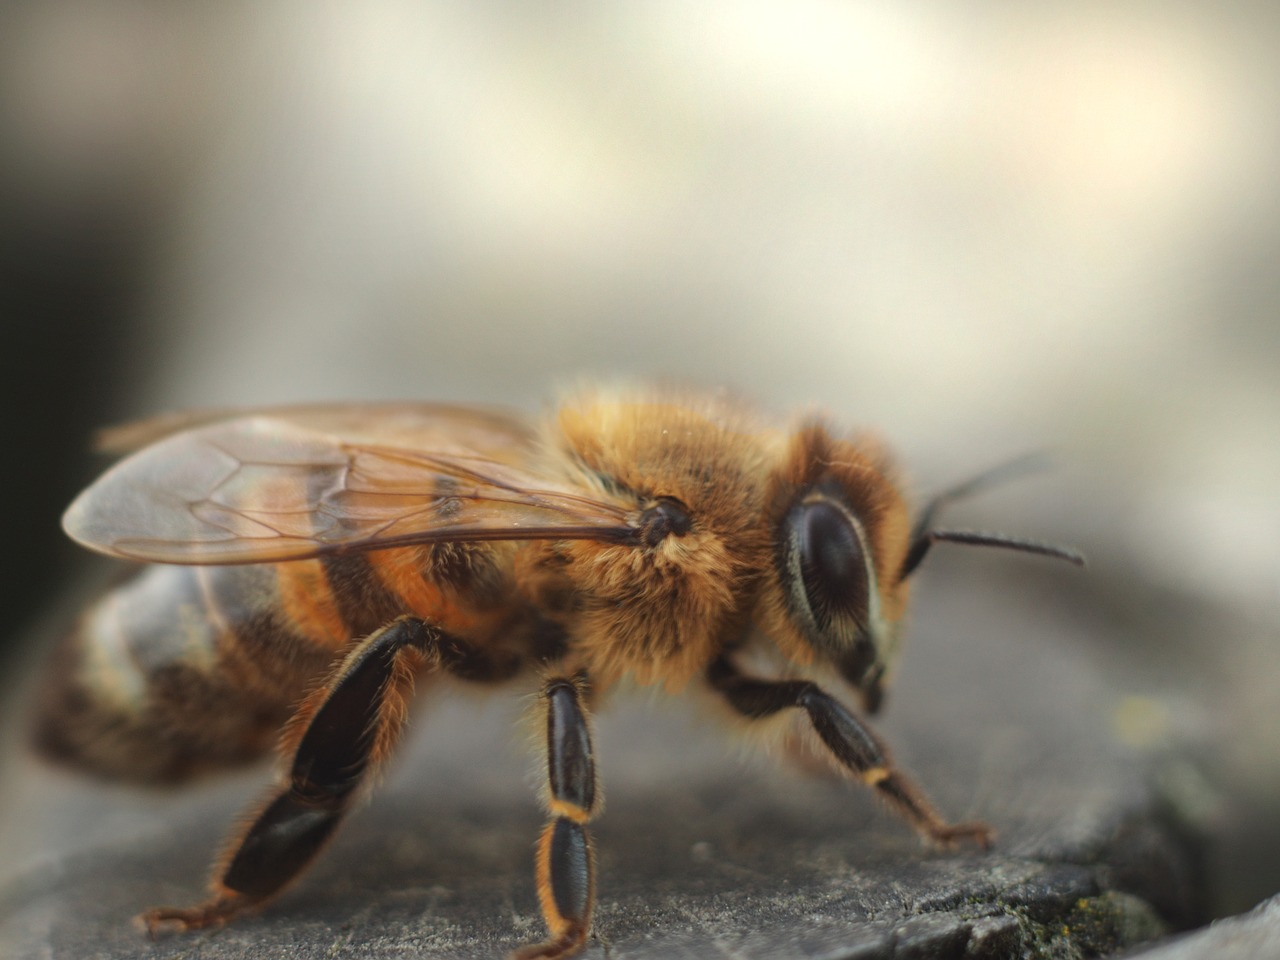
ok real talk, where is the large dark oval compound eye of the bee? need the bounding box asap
[787,499,870,640]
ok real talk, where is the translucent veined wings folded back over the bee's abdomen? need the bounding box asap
[63,404,635,563]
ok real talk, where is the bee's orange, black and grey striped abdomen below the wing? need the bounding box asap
[37,549,514,781]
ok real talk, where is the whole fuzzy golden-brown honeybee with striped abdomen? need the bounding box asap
[37,389,1082,960]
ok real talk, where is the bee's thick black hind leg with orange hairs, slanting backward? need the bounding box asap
[138,617,513,933]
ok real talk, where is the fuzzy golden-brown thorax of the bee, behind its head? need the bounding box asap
[542,398,778,690]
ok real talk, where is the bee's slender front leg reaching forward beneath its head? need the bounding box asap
[707,658,995,847]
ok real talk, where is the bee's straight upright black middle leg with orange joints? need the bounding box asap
[515,677,599,960]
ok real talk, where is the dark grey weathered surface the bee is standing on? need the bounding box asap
[0,561,1206,960]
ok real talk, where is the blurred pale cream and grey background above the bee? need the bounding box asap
[0,0,1280,931]
